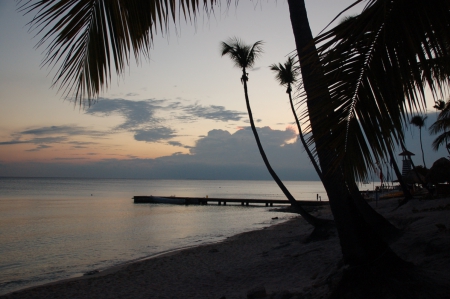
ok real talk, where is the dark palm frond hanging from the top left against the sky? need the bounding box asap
[20,0,220,103]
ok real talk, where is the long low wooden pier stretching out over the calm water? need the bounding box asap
[133,196,328,207]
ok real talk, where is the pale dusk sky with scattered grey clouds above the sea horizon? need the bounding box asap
[0,0,446,180]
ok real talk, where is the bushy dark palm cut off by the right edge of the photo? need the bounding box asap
[429,100,450,154]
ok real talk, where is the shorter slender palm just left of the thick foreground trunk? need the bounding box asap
[270,56,322,180]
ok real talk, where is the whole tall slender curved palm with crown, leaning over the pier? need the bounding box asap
[221,37,329,227]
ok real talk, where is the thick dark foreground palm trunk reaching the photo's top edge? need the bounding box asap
[288,0,396,266]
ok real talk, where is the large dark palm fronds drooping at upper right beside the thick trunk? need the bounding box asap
[310,0,450,179]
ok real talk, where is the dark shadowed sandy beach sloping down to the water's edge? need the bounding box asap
[0,198,450,299]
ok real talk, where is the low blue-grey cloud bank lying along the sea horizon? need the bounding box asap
[0,127,324,180]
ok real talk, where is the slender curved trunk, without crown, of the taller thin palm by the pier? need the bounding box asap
[242,69,330,227]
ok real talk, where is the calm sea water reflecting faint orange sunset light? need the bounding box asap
[0,178,326,294]
